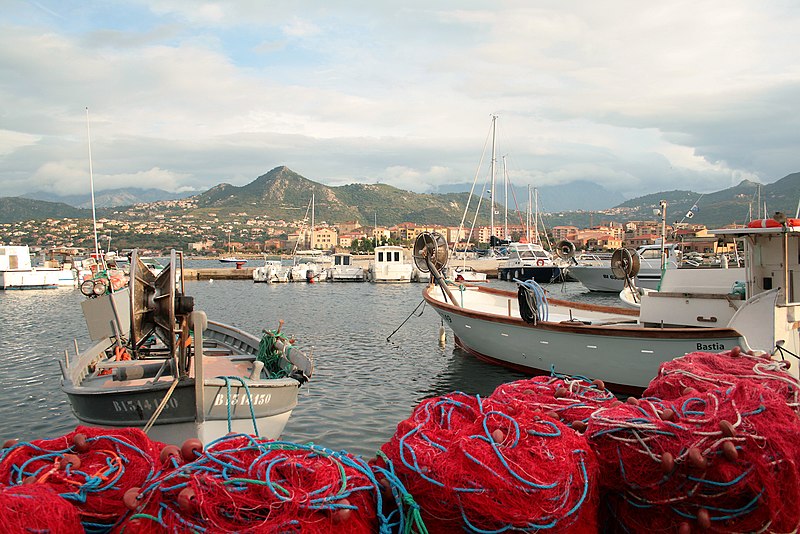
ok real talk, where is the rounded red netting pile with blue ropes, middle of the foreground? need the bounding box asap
[382,393,598,532]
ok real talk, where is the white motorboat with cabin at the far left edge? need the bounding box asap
[0,245,69,290]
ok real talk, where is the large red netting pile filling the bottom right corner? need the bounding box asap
[586,383,800,533]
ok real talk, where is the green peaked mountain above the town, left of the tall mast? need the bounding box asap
[193,167,472,225]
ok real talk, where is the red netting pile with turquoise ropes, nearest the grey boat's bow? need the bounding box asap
[121,434,422,534]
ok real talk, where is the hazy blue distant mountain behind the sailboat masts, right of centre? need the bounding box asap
[436,180,624,212]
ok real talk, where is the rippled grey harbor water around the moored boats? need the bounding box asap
[0,262,616,457]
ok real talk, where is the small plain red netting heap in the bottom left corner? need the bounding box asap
[0,484,83,534]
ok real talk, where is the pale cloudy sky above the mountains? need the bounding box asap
[0,0,800,202]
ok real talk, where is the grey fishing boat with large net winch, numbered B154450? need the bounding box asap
[60,251,314,444]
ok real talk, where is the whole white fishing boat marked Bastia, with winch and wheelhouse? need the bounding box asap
[414,219,800,393]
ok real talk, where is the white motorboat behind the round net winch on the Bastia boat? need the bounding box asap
[568,243,680,293]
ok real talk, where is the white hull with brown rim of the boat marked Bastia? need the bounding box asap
[423,287,746,393]
